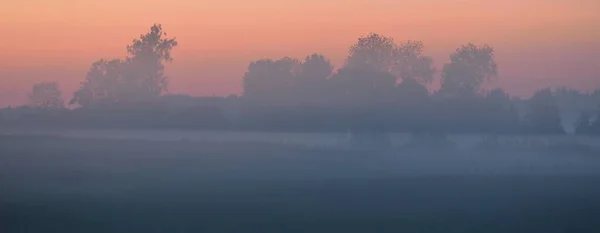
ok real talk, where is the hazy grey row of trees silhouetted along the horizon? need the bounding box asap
[1,24,600,134]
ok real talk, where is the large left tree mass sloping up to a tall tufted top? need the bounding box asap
[69,24,177,107]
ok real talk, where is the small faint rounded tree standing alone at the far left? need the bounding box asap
[29,82,65,109]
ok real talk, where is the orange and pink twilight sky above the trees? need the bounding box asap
[0,0,600,106]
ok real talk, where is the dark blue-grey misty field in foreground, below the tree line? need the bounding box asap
[0,133,600,233]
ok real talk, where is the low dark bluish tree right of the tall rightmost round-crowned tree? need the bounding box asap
[528,89,564,134]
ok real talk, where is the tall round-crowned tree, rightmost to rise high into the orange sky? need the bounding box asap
[440,43,498,96]
